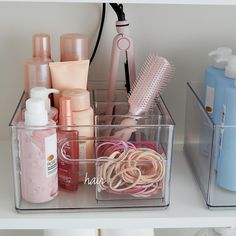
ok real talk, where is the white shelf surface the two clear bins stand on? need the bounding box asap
[0,142,236,229]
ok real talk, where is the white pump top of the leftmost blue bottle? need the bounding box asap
[208,47,232,69]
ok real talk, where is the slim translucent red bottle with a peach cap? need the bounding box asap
[57,97,79,191]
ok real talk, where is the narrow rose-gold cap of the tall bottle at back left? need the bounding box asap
[33,33,52,62]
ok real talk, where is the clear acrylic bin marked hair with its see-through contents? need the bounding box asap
[10,89,175,212]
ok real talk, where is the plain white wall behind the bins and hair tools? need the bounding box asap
[0,2,236,141]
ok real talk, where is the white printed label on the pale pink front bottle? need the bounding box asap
[45,134,57,177]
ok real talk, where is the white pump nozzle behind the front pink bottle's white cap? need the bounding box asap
[30,87,59,112]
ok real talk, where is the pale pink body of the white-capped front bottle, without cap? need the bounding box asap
[19,125,58,203]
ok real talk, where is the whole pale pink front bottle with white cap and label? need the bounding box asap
[18,98,58,203]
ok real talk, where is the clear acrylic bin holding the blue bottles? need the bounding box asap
[184,82,236,209]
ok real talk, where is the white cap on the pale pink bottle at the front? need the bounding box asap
[25,98,48,126]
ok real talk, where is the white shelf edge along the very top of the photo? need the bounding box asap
[0,0,236,5]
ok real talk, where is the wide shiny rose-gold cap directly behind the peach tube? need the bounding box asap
[60,33,88,61]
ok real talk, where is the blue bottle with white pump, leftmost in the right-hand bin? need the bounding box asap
[200,47,233,159]
